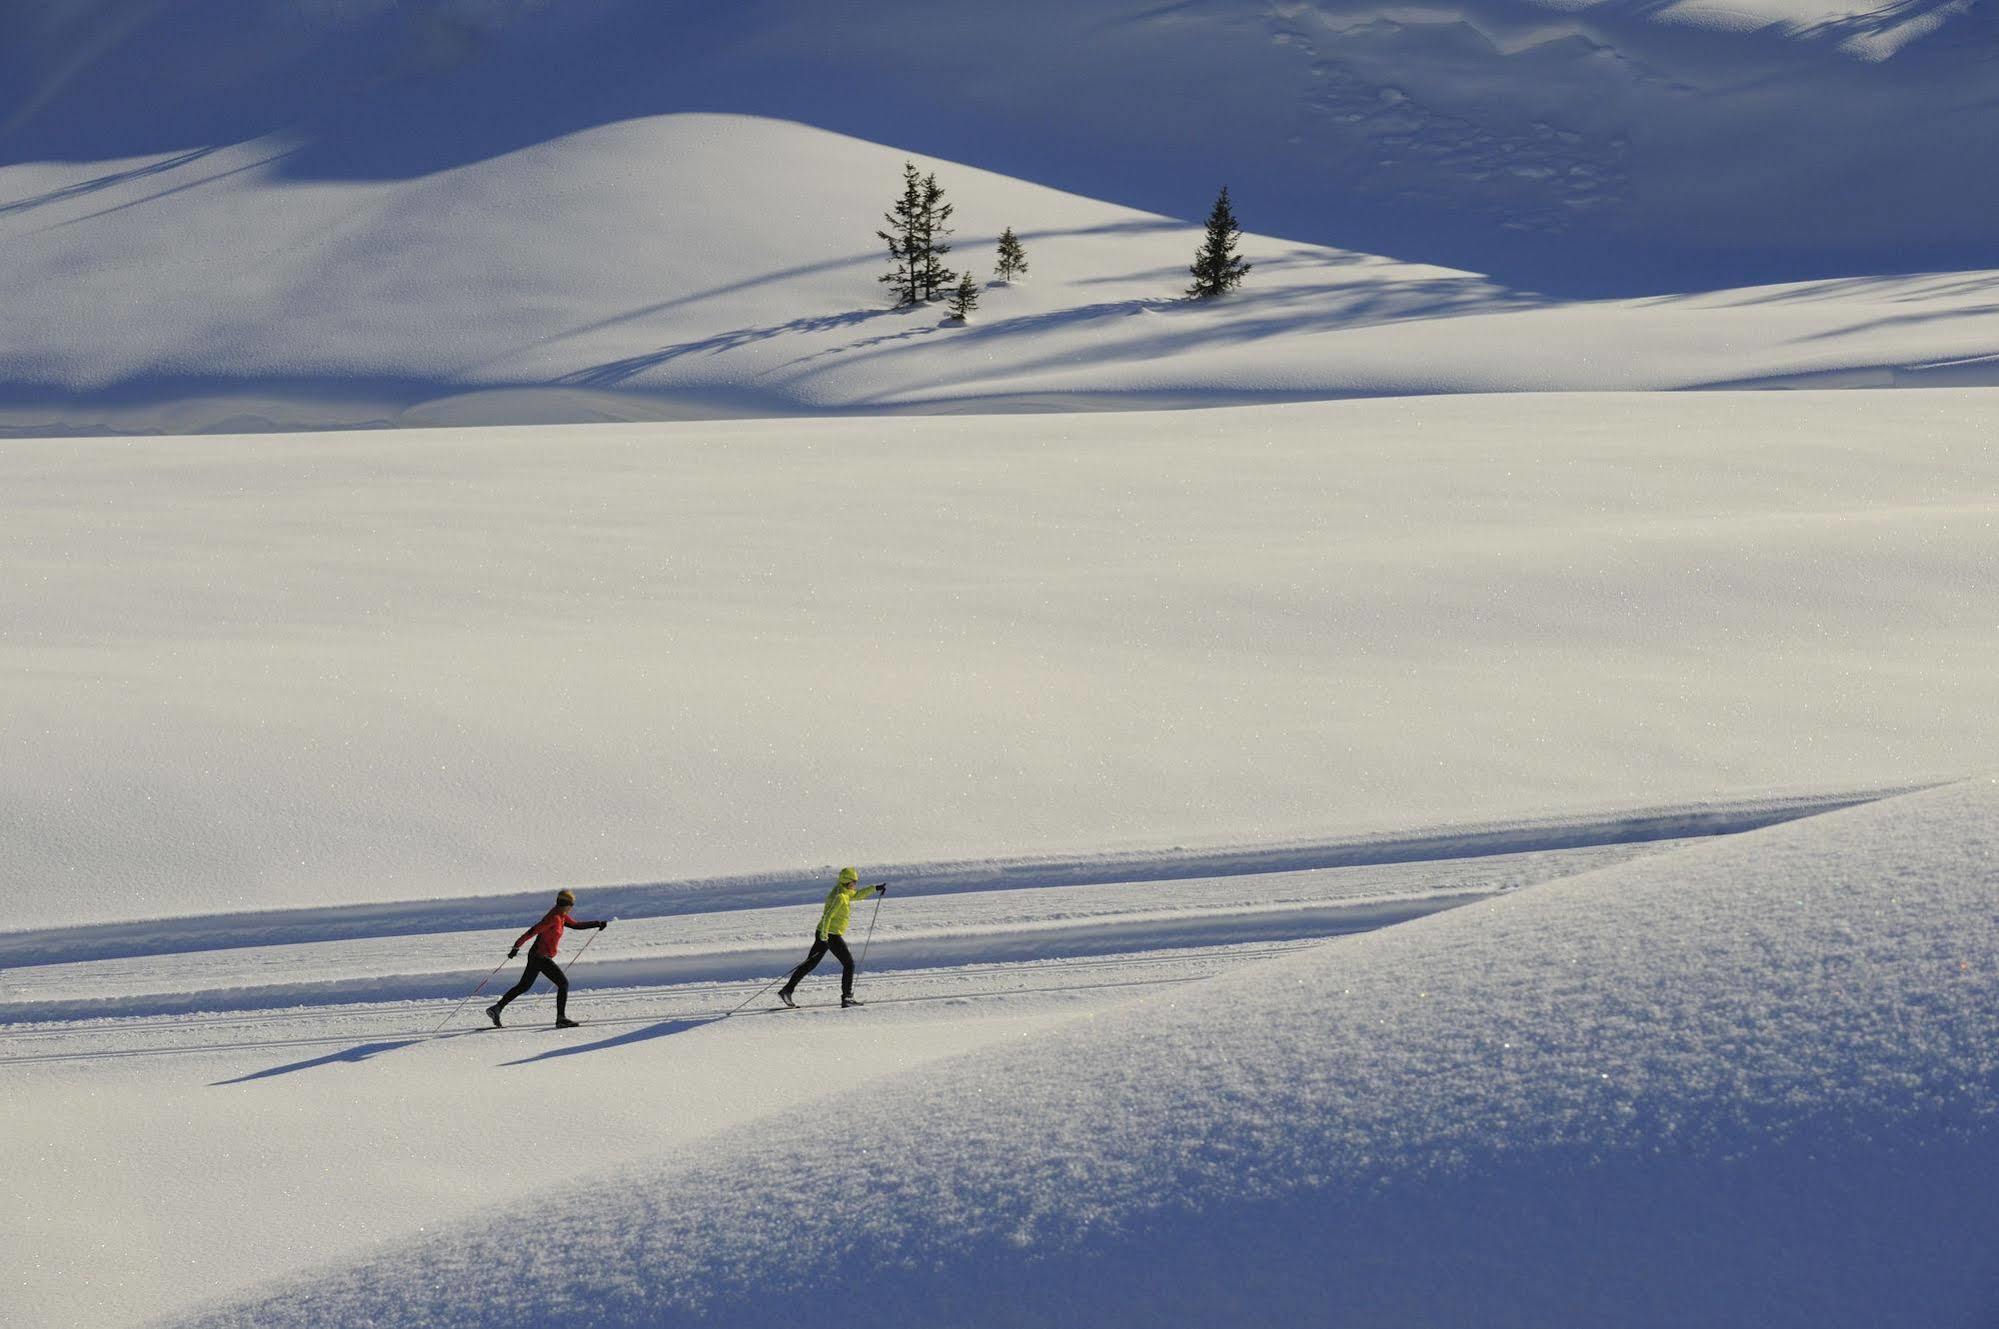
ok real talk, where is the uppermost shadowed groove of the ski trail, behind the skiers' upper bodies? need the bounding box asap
[0,783,1929,971]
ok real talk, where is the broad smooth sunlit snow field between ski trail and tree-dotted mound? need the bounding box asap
[0,392,1999,927]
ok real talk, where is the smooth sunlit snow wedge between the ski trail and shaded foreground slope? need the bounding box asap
[0,975,1129,1329]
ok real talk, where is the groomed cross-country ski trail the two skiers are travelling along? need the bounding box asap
[0,789,1905,1039]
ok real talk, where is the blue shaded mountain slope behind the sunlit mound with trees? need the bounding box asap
[0,0,1999,294]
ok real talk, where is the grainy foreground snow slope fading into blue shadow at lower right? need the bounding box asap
[167,779,1999,1329]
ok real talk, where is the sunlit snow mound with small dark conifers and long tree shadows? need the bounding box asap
[0,114,1999,436]
